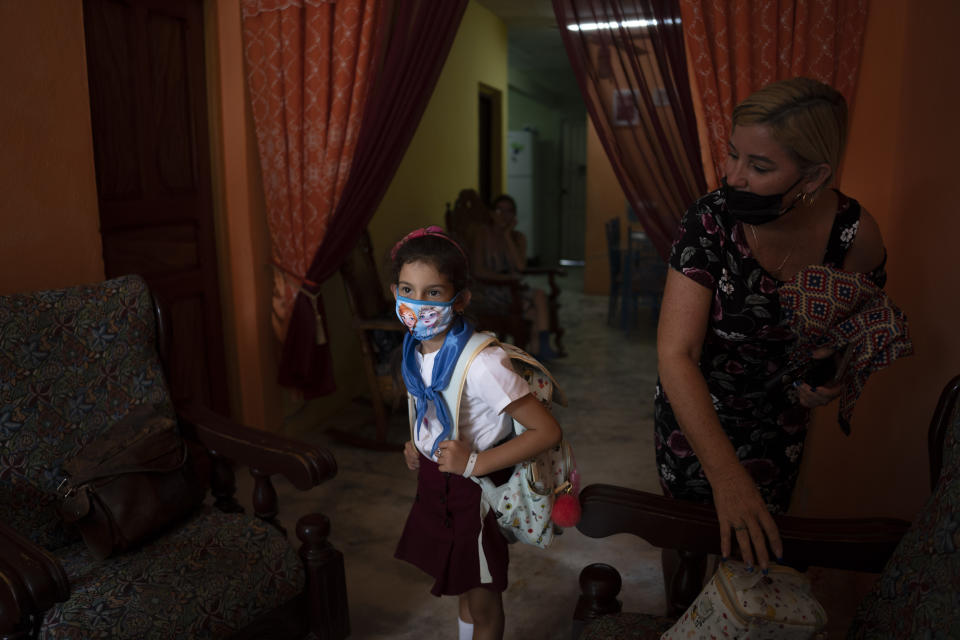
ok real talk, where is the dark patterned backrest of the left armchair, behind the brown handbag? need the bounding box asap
[0,276,173,549]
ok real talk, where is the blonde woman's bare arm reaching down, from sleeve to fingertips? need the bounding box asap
[657,269,783,569]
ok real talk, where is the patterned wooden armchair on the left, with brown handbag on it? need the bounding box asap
[0,276,349,640]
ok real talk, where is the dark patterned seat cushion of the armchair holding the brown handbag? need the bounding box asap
[40,510,304,640]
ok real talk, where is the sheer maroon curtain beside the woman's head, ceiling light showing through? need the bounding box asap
[553,0,706,259]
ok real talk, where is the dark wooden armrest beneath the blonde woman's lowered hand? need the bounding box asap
[577,484,910,573]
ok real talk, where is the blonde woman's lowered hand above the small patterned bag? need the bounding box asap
[710,464,783,570]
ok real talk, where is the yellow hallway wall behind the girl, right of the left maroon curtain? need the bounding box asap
[296,1,507,432]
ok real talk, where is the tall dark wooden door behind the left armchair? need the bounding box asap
[83,0,228,413]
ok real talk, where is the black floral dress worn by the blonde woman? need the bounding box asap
[654,191,885,513]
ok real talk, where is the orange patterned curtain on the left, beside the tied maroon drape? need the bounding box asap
[241,0,381,339]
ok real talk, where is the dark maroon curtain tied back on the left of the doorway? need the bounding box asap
[279,0,467,397]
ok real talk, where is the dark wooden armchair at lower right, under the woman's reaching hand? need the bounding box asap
[573,376,960,640]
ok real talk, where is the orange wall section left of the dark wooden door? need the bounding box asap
[0,0,104,293]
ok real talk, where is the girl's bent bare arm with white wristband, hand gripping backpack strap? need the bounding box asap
[439,394,563,476]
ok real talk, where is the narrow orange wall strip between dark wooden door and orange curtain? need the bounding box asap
[204,0,281,429]
